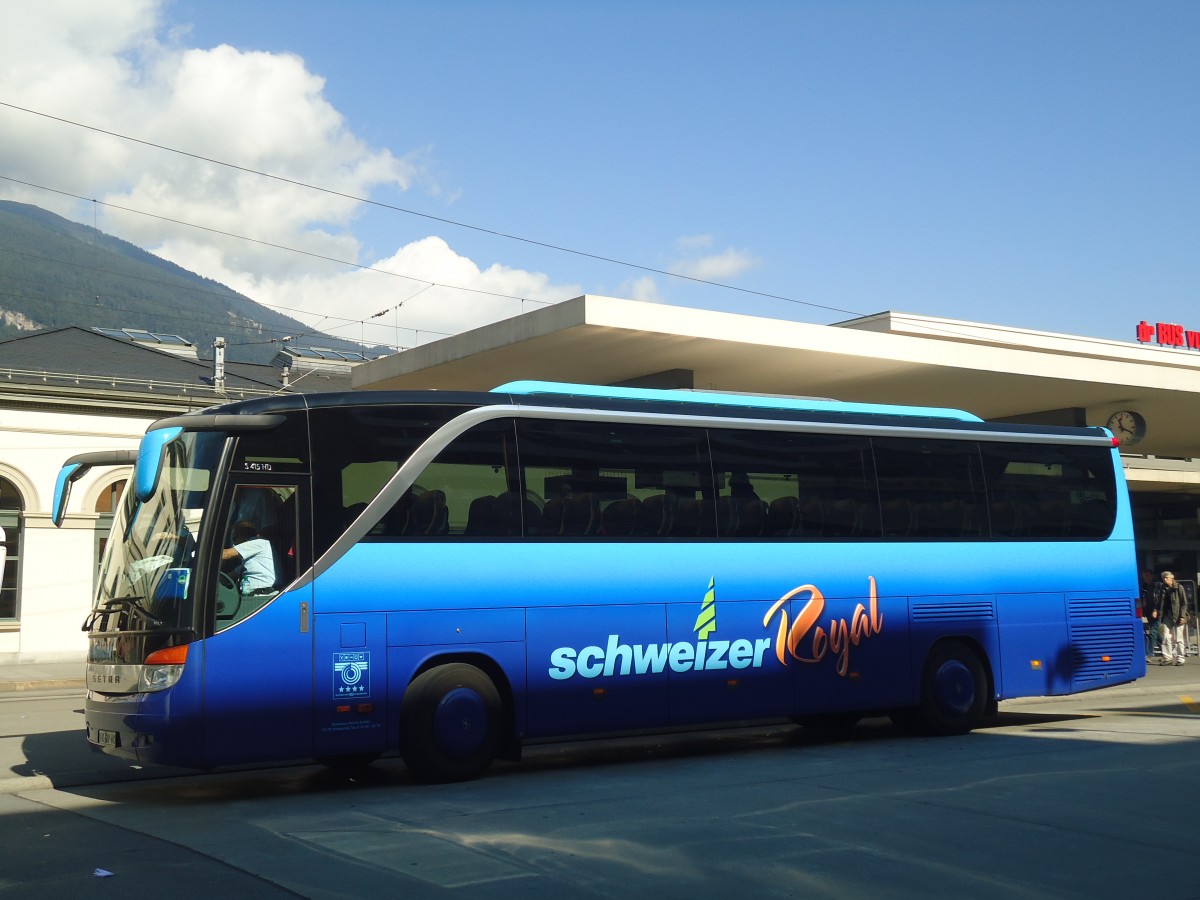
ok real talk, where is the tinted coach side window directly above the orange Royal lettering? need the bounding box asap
[710,431,880,539]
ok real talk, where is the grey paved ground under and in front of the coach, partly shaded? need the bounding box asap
[9,676,1200,900]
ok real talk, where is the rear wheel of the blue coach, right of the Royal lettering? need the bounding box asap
[912,641,989,734]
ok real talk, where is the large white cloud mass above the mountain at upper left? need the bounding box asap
[0,0,582,344]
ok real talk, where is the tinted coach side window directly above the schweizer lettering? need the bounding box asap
[517,420,716,539]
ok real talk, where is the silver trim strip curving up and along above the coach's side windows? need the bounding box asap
[297,403,1112,590]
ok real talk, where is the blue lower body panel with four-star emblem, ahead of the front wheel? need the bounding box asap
[313,613,388,758]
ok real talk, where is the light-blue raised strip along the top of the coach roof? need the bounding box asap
[492,380,983,422]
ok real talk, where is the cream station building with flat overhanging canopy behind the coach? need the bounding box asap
[0,295,1200,662]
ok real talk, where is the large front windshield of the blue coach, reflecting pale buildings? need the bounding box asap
[84,432,224,664]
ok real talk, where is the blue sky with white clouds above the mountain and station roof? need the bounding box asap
[0,0,1200,346]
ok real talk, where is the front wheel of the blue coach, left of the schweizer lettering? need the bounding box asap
[400,662,504,782]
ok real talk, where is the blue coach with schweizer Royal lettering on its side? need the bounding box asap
[55,382,1145,780]
